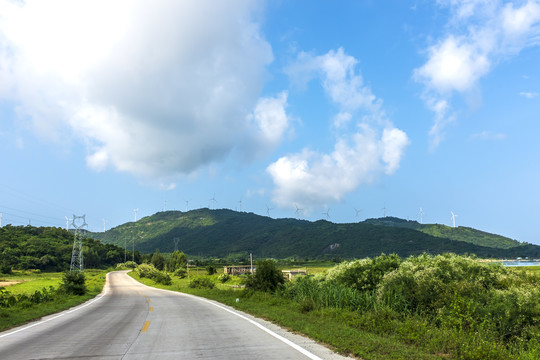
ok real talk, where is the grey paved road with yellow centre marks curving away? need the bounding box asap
[0,272,350,360]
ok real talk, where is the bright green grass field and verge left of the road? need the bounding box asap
[0,270,107,331]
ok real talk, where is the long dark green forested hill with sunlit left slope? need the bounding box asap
[91,209,540,258]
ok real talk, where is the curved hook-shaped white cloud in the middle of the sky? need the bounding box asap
[267,48,409,211]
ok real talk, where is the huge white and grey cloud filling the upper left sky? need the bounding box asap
[0,0,288,178]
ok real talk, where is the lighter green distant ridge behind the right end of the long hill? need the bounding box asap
[364,216,522,249]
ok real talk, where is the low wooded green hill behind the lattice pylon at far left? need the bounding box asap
[0,225,124,272]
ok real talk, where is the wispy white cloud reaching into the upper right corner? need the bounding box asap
[413,0,540,148]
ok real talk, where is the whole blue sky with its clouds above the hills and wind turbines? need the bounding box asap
[0,0,540,244]
